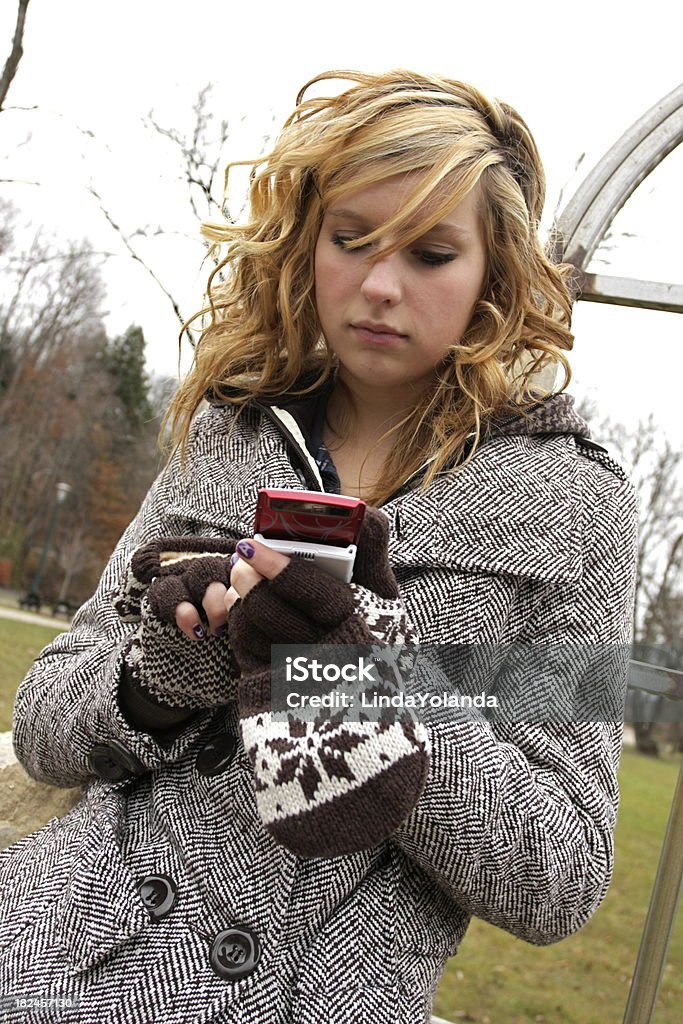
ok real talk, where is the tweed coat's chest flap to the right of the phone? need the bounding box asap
[385,434,585,582]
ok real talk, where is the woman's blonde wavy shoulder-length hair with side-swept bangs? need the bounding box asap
[167,70,572,505]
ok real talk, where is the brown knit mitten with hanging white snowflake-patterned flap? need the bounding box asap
[228,510,428,857]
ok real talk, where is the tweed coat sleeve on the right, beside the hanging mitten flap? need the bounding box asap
[392,460,637,945]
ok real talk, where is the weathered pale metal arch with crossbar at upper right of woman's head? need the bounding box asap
[553,84,683,313]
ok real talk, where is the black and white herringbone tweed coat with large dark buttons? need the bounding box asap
[0,391,636,1024]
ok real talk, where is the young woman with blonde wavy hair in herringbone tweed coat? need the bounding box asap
[0,71,635,1024]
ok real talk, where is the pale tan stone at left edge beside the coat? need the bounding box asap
[0,732,81,850]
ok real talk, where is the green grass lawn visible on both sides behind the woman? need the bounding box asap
[0,618,683,1024]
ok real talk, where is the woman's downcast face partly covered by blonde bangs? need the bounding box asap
[315,174,486,393]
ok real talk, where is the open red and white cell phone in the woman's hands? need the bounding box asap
[254,487,366,583]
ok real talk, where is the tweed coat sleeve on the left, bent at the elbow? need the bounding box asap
[13,436,216,786]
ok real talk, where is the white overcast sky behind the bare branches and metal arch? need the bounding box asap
[0,0,683,442]
